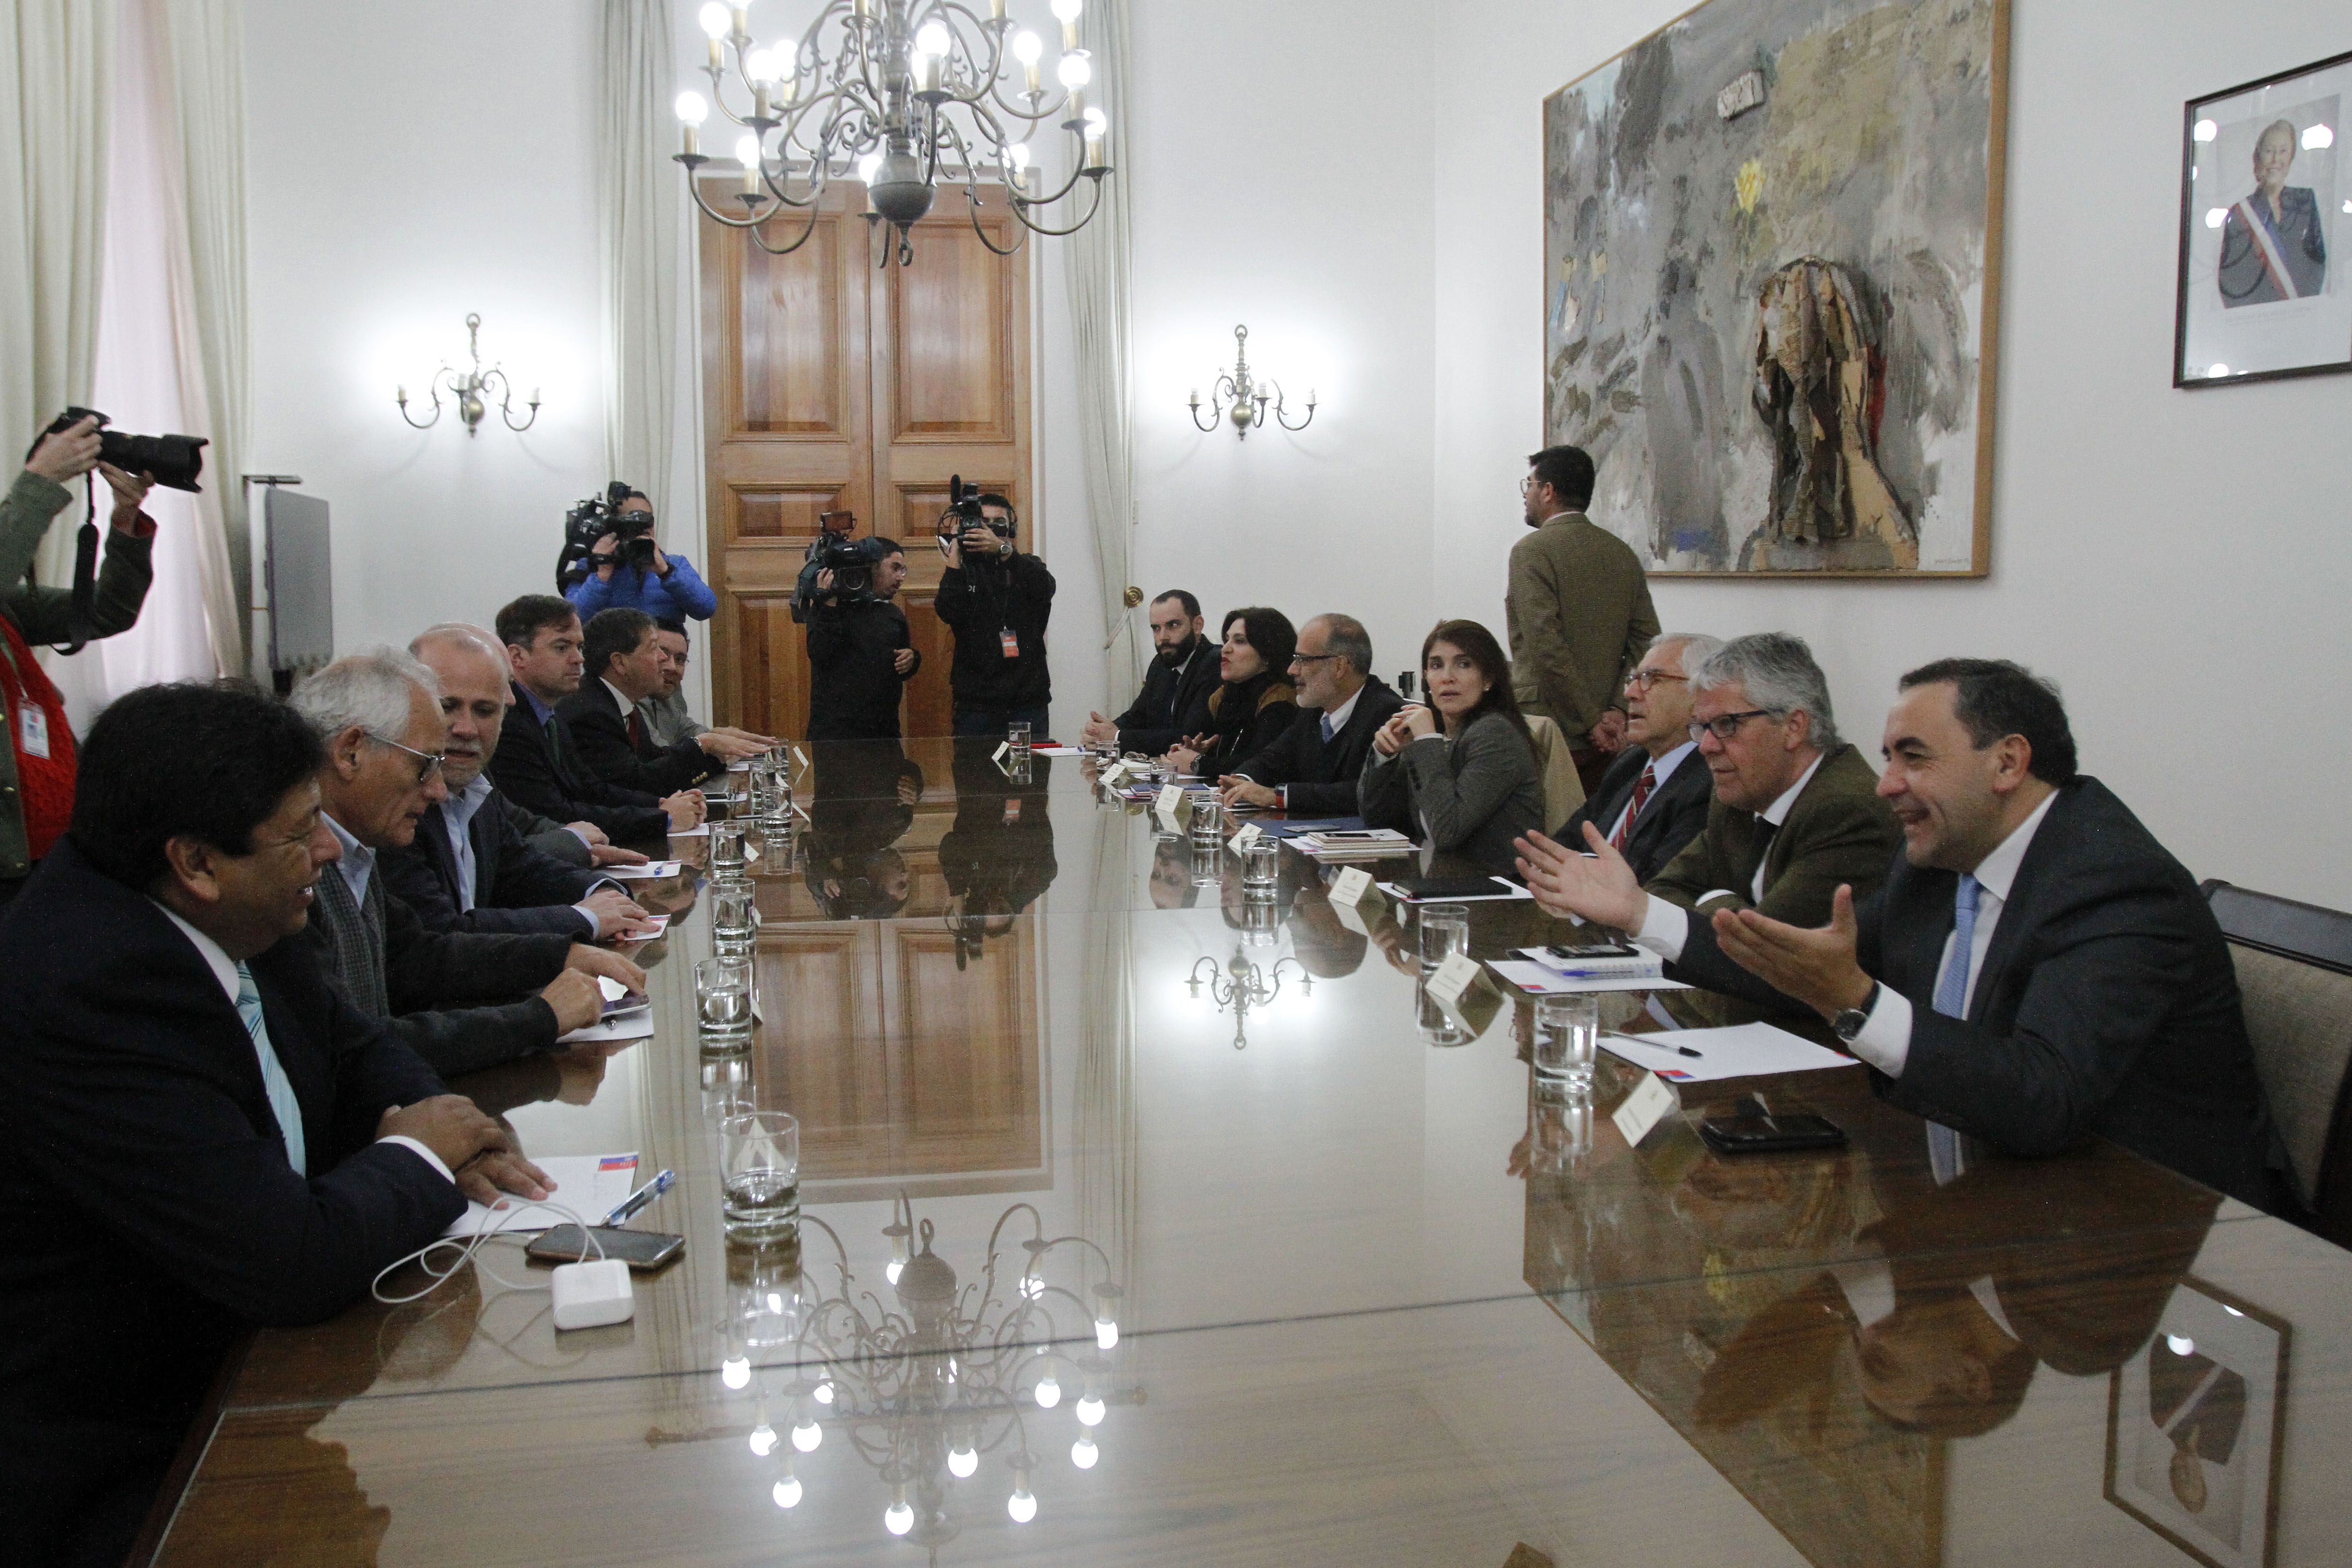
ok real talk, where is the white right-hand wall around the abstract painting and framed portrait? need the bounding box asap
[1411,0,2352,908]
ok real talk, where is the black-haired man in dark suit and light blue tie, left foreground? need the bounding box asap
[0,684,548,1568]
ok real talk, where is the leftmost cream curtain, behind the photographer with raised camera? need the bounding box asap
[0,0,115,585]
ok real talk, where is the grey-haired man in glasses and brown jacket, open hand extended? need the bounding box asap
[1520,632,1903,992]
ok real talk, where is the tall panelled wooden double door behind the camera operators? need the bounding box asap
[699,179,1035,736]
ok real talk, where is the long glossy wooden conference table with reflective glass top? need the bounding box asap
[142,740,2352,1568]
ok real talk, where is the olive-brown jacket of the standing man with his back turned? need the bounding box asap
[1503,512,1658,745]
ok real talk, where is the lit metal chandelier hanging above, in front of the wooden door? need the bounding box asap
[675,0,1110,266]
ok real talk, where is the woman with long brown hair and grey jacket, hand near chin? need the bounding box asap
[1357,621,1543,872]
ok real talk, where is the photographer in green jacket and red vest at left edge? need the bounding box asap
[0,416,155,903]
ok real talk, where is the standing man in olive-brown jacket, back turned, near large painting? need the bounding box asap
[1503,447,1658,797]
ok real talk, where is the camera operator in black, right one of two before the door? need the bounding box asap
[939,494,1054,738]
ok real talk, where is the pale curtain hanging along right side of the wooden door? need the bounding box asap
[1065,0,1136,703]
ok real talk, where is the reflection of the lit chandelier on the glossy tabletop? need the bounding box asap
[720,1194,1143,1561]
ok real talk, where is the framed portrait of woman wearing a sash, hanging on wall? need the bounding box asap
[2173,54,2352,388]
